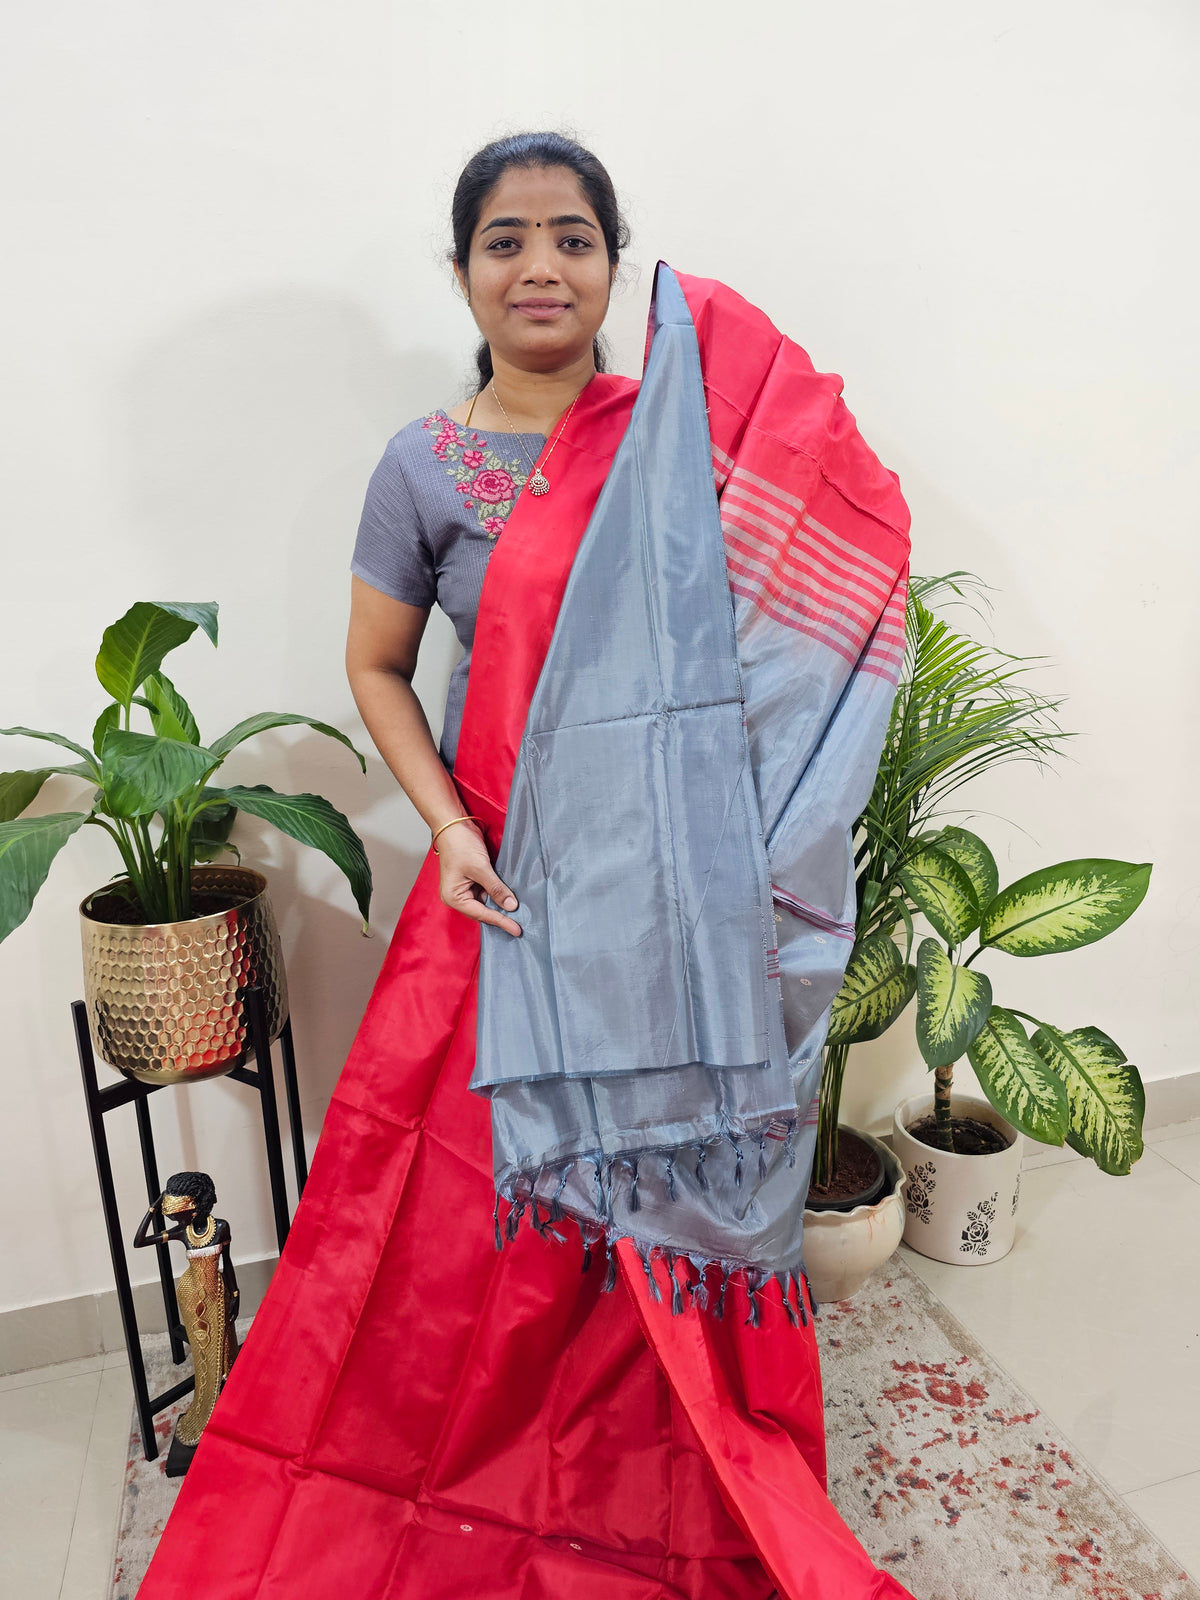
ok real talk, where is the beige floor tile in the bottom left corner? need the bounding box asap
[0,1370,101,1600]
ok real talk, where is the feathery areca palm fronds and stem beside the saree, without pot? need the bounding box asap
[813,571,1070,1186]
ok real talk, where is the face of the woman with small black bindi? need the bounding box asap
[454,166,614,373]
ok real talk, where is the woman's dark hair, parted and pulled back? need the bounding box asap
[450,133,629,389]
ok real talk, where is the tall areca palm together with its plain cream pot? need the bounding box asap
[805,571,1067,1299]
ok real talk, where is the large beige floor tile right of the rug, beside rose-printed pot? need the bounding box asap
[904,1147,1200,1493]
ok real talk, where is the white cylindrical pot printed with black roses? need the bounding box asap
[891,1093,1024,1267]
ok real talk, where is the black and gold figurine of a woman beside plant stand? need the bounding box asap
[133,1173,238,1478]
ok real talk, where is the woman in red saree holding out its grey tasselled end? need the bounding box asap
[141,134,907,1600]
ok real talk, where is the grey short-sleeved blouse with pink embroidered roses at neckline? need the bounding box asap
[350,408,546,770]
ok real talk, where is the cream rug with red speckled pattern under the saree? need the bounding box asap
[112,1256,1200,1600]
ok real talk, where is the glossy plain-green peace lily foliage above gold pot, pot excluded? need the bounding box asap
[0,600,371,939]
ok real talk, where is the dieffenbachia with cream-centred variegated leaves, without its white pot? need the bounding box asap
[829,827,1150,1174]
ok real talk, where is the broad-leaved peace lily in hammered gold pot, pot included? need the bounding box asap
[0,600,371,1083]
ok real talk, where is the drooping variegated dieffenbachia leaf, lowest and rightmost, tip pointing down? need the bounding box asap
[1030,1022,1146,1176]
